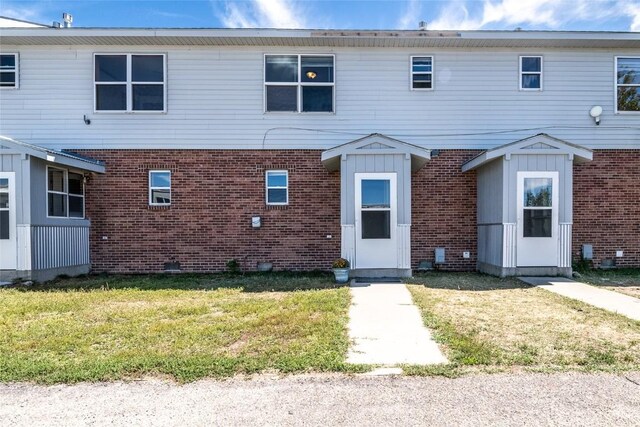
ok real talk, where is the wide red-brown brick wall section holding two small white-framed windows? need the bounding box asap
[82,150,340,273]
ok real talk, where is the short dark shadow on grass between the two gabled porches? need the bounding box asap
[404,271,532,291]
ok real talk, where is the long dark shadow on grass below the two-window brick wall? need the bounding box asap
[12,271,346,292]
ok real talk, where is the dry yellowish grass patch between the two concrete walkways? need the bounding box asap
[406,273,640,376]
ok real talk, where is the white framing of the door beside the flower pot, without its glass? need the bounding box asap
[353,172,398,268]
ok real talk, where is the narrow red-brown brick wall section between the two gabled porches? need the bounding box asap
[411,150,478,271]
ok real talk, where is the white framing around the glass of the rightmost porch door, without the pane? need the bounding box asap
[516,171,560,267]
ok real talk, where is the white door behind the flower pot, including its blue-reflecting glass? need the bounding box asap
[355,173,398,268]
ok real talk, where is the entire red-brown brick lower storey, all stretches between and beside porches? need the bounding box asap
[81,150,640,273]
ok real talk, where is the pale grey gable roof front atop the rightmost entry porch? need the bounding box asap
[462,133,593,172]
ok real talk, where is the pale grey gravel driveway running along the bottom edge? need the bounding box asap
[0,372,640,426]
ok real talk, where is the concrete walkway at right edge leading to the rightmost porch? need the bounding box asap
[520,277,640,321]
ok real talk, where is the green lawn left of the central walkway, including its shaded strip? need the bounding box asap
[0,273,356,383]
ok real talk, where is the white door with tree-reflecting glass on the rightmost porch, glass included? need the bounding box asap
[516,172,559,267]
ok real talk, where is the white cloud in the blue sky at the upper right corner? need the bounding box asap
[429,0,640,31]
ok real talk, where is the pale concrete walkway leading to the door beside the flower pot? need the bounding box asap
[347,283,447,366]
